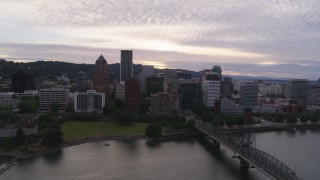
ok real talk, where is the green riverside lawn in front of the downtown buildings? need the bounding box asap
[61,121,148,141]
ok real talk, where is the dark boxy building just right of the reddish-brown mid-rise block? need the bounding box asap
[146,75,164,97]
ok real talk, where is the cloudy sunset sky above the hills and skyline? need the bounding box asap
[0,0,320,79]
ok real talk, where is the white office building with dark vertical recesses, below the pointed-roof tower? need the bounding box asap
[73,90,105,112]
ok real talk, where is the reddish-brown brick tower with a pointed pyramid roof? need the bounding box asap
[93,55,109,104]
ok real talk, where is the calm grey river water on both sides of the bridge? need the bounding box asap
[0,130,320,180]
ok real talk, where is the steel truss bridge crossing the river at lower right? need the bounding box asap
[195,121,298,180]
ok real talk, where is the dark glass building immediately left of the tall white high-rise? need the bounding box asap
[179,82,201,109]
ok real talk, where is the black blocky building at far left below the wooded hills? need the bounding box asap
[11,71,36,93]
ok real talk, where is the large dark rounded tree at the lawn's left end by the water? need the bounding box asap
[42,125,63,147]
